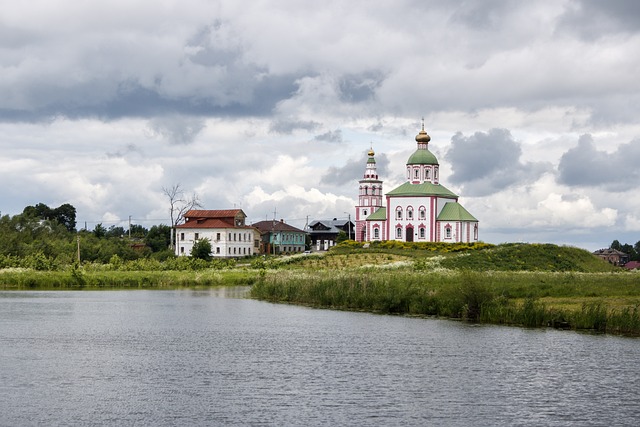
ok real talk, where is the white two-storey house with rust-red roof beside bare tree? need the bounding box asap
[175,209,260,258]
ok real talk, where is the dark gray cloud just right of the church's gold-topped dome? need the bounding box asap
[445,129,552,196]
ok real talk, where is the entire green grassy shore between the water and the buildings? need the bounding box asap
[0,241,640,335]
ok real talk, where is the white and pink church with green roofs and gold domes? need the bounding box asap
[355,120,478,243]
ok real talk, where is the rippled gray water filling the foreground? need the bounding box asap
[0,289,640,426]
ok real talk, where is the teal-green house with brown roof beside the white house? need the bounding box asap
[252,219,307,254]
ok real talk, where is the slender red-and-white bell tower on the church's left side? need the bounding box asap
[355,147,382,242]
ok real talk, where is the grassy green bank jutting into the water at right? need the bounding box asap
[251,270,640,335]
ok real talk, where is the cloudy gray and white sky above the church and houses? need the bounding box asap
[0,0,640,250]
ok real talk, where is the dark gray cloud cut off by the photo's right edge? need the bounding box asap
[558,134,640,192]
